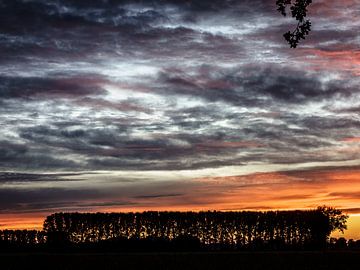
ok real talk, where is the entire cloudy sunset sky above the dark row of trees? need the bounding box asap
[0,0,360,239]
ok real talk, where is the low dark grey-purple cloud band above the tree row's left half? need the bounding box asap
[0,176,188,214]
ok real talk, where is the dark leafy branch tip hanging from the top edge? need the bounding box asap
[276,0,312,48]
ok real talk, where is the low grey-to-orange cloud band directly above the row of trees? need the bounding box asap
[0,167,359,213]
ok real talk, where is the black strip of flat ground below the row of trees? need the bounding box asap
[0,251,360,270]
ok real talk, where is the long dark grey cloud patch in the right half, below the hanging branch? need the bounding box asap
[159,66,354,107]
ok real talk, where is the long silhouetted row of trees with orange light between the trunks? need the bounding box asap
[0,207,347,249]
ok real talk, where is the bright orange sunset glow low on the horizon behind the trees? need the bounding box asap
[0,168,360,239]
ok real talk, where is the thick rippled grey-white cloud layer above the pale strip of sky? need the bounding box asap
[0,0,360,170]
